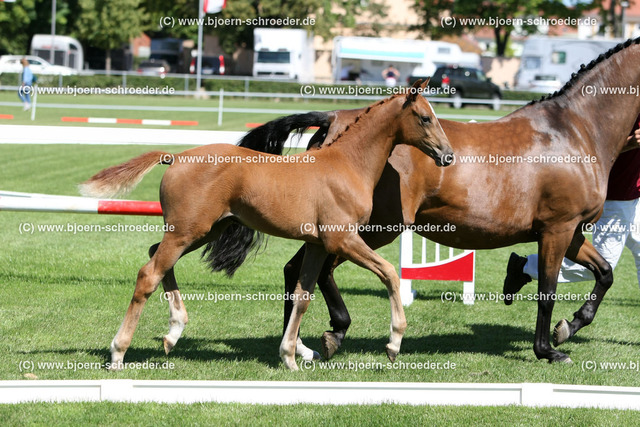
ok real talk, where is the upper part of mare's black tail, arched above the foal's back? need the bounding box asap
[238,111,331,154]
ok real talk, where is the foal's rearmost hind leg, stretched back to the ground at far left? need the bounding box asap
[110,233,192,369]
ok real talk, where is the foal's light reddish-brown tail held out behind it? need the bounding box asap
[78,151,173,197]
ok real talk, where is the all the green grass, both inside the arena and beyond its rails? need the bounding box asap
[0,98,640,425]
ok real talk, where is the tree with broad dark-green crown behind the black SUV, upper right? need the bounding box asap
[414,0,593,56]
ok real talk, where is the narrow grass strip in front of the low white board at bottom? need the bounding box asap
[0,403,638,426]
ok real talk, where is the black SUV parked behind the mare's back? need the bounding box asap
[407,65,502,110]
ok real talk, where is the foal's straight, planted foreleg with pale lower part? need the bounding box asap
[280,243,327,371]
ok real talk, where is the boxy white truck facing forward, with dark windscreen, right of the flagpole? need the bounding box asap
[253,28,315,83]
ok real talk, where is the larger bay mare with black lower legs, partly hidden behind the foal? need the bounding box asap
[209,39,640,362]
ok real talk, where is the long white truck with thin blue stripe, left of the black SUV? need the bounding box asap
[331,37,481,83]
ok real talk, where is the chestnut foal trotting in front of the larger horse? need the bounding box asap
[80,81,453,370]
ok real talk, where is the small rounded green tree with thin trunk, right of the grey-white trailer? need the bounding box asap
[76,0,149,71]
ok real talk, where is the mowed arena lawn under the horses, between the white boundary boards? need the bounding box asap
[0,145,640,386]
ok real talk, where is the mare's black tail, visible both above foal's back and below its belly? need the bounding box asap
[202,111,330,277]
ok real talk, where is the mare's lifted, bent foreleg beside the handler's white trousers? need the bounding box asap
[553,232,613,346]
